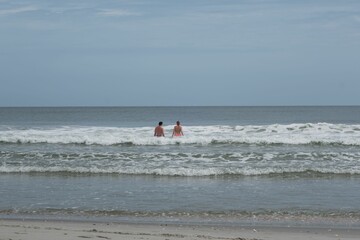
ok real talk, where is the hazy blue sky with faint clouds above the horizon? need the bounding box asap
[0,0,360,107]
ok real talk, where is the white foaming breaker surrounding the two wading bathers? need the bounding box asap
[0,123,360,146]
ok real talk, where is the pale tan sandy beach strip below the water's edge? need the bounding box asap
[0,220,360,240]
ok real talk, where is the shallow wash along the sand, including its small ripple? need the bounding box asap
[0,213,360,230]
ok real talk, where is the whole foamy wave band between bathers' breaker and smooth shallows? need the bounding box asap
[0,151,360,177]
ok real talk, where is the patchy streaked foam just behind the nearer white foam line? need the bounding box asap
[0,150,360,162]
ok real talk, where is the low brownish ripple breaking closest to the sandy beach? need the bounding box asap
[0,207,360,221]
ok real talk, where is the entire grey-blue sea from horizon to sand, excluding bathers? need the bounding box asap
[0,106,360,227]
